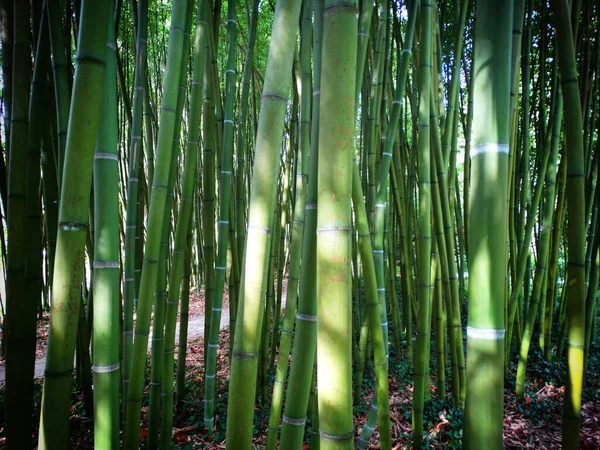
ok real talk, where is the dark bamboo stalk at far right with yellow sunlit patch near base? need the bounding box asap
[552,0,585,449]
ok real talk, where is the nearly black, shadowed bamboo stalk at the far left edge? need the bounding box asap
[3,2,33,449]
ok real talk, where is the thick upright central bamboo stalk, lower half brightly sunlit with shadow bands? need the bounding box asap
[316,0,358,450]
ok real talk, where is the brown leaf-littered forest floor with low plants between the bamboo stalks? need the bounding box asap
[0,280,600,450]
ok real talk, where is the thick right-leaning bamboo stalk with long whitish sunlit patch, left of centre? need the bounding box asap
[227,0,301,442]
